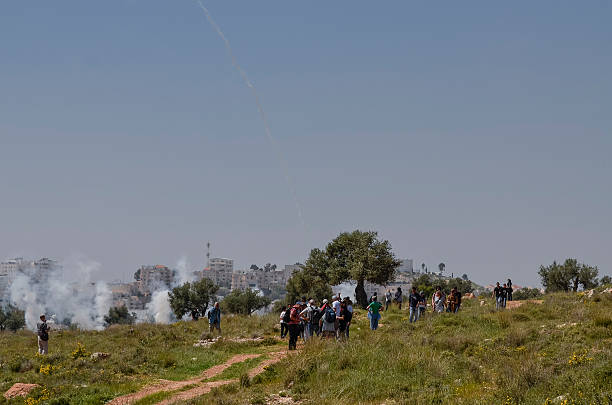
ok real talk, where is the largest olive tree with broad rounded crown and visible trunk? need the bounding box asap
[325,230,401,308]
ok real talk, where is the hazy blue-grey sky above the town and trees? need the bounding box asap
[0,0,612,284]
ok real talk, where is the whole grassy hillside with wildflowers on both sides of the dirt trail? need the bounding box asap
[0,293,612,405]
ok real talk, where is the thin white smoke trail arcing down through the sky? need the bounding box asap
[198,0,306,227]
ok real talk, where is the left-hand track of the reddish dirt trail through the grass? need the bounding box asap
[108,354,261,405]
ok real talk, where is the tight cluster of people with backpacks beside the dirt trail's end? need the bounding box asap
[280,294,353,350]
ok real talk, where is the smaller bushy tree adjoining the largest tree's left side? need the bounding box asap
[285,249,332,304]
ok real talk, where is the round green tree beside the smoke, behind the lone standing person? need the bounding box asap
[168,278,219,321]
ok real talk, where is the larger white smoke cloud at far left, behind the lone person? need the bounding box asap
[10,258,112,330]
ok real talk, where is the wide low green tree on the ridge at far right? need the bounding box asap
[538,259,599,292]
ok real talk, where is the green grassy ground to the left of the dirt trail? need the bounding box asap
[0,315,281,404]
